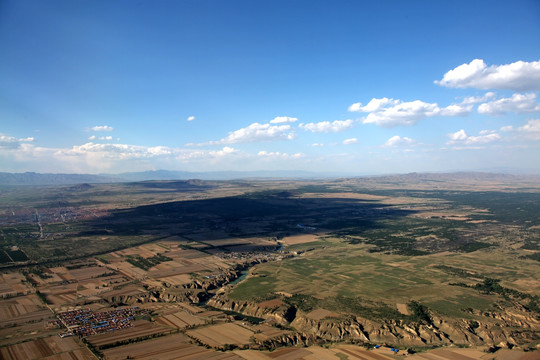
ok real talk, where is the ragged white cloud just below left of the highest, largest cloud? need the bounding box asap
[349,98,442,127]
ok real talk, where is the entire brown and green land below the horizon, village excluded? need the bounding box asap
[0,174,540,360]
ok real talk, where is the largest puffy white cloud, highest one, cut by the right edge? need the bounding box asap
[435,59,540,91]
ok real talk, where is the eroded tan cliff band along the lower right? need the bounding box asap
[208,295,540,346]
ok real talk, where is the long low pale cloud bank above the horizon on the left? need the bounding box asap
[0,135,316,173]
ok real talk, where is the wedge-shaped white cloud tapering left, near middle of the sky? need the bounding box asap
[209,123,296,145]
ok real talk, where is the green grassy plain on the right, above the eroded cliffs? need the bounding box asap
[229,180,540,324]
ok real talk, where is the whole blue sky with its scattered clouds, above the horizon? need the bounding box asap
[0,0,540,174]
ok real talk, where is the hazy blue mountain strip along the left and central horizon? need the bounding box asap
[0,170,344,185]
